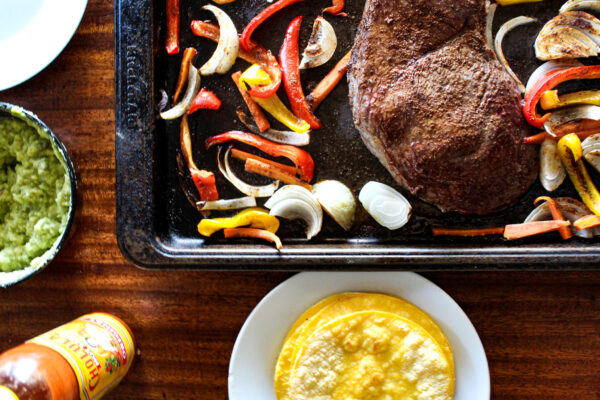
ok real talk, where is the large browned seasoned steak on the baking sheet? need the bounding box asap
[348,0,537,214]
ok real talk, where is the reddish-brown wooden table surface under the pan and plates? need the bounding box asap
[0,0,600,400]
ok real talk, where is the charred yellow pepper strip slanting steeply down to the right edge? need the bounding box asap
[557,133,600,215]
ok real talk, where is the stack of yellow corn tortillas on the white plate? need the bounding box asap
[275,293,454,400]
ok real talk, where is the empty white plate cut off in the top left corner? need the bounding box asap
[0,0,87,90]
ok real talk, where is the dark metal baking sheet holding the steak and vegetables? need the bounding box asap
[115,0,600,270]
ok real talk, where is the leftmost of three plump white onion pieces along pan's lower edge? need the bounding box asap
[265,185,323,240]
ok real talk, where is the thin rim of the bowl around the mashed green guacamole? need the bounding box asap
[0,102,78,288]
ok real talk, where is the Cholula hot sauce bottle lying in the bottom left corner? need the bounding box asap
[0,313,135,400]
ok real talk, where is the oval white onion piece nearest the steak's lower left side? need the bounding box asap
[358,181,412,230]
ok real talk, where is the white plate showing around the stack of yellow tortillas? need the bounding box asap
[229,272,490,400]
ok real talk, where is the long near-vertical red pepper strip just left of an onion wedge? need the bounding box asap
[279,17,323,129]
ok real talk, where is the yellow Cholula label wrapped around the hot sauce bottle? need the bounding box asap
[29,313,135,400]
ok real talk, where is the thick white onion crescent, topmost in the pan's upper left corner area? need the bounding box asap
[200,5,240,75]
